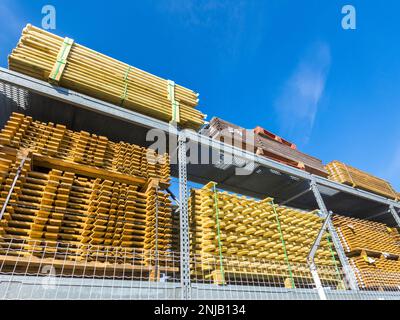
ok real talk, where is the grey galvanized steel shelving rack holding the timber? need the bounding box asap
[0,68,400,299]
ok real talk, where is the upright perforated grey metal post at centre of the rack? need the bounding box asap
[178,133,191,300]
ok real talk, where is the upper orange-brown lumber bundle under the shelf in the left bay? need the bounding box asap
[0,113,170,183]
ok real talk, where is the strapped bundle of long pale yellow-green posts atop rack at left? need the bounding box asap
[9,25,205,129]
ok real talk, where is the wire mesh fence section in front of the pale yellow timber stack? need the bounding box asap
[191,255,346,300]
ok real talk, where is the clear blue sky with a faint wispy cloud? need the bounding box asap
[0,0,400,190]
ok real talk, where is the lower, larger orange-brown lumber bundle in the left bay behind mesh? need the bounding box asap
[0,149,173,272]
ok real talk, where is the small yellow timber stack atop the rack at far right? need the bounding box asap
[326,161,398,199]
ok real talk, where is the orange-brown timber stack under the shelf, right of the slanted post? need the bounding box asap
[333,216,400,290]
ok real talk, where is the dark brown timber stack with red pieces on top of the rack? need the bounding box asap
[201,118,328,177]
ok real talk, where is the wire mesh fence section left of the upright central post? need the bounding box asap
[0,238,180,300]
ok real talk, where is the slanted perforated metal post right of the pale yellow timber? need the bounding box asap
[310,179,358,290]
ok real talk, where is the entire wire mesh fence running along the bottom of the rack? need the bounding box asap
[0,238,400,300]
